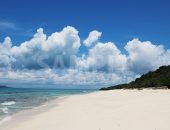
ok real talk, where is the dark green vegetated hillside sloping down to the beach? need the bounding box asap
[100,66,170,90]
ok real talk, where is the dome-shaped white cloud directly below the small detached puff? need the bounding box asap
[78,42,126,72]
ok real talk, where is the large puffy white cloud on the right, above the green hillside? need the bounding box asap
[125,39,170,74]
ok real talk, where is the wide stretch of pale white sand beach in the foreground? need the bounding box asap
[0,89,170,130]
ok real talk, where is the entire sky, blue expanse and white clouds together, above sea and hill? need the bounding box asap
[0,0,170,87]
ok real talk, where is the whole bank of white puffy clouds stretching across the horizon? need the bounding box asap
[0,26,170,88]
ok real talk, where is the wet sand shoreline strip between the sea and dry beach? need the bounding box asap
[0,91,95,130]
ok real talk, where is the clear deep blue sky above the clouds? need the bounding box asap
[0,0,170,48]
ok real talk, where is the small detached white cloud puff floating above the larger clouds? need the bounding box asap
[83,30,102,47]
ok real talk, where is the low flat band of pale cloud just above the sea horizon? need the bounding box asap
[0,69,133,87]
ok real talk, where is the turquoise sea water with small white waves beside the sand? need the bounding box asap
[0,88,94,119]
